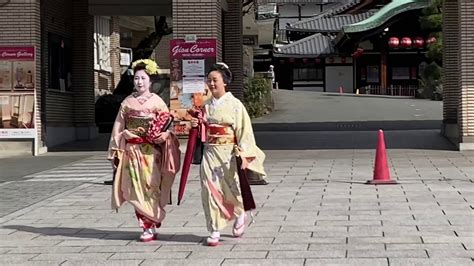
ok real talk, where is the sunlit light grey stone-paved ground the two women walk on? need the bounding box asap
[0,149,474,266]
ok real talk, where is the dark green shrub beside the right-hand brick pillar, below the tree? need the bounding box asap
[419,62,443,100]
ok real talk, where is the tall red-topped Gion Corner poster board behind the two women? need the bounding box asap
[170,39,217,135]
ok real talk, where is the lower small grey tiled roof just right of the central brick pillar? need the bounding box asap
[273,33,335,57]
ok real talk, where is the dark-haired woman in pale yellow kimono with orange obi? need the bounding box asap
[191,63,265,246]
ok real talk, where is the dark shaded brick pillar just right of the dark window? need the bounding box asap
[72,0,97,140]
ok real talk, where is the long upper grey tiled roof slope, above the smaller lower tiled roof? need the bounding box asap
[288,11,375,32]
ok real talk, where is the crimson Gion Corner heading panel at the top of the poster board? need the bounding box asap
[170,39,217,58]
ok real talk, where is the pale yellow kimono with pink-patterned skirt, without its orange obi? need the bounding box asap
[200,92,266,232]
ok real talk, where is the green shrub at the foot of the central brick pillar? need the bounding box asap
[244,78,272,118]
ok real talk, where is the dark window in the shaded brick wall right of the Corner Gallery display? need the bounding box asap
[48,33,72,91]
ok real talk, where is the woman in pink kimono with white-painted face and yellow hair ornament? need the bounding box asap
[108,59,180,242]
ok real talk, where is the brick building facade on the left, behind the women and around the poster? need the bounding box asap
[0,0,243,154]
